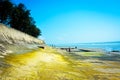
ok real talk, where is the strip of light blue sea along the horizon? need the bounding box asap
[52,41,120,51]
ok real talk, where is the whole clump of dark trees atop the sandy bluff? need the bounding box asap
[0,0,41,37]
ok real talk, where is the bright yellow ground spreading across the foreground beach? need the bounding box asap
[0,47,120,80]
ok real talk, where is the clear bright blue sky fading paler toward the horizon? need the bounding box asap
[12,0,120,44]
